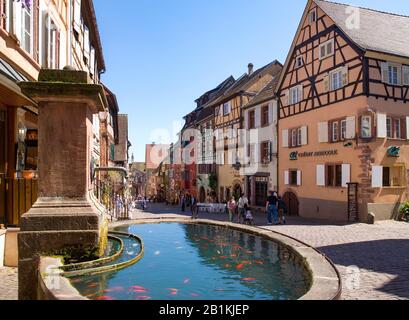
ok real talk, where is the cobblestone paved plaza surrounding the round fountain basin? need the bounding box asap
[0,204,409,300]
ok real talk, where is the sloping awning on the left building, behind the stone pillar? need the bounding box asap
[0,58,36,107]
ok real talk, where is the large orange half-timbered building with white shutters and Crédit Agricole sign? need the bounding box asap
[277,0,409,222]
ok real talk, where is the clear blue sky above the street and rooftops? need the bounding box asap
[94,0,409,161]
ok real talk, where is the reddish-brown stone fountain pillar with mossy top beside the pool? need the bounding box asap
[18,70,107,300]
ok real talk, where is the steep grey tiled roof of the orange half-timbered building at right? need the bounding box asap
[314,0,409,57]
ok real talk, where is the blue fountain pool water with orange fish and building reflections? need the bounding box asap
[72,223,309,300]
